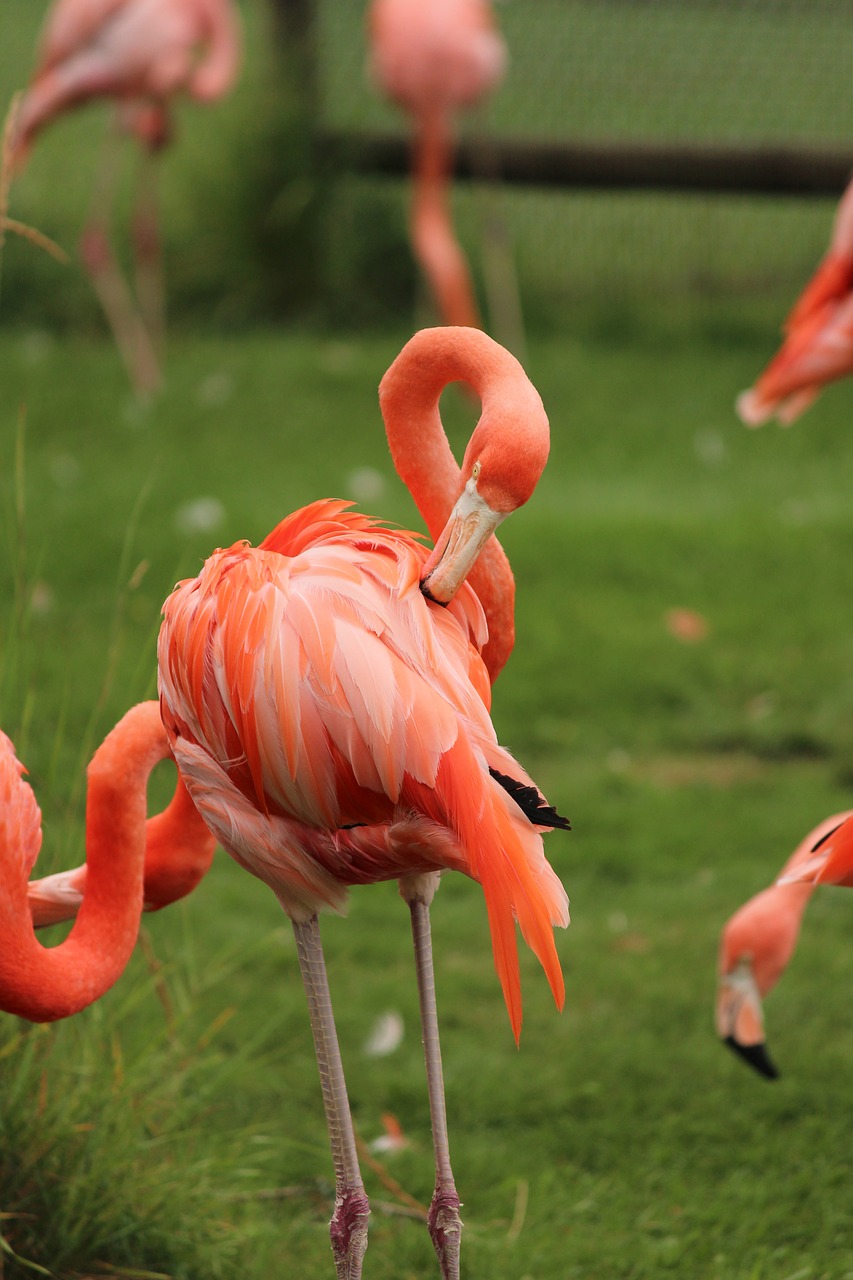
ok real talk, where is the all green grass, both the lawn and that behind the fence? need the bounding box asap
[0,0,853,1280]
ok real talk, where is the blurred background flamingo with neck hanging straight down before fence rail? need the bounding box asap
[369,0,506,326]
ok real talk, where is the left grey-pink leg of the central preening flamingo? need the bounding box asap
[292,915,370,1280]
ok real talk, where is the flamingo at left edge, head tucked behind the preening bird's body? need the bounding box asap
[0,700,214,1023]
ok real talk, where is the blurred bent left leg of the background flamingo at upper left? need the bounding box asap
[81,126,160,397]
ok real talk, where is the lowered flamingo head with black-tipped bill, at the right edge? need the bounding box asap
[716,810,853,1080]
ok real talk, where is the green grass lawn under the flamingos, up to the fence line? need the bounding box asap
[0,305,853,1280]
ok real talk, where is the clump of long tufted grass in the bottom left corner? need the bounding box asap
[0,931,281,1280]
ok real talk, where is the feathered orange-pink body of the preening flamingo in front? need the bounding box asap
[159,502,569,1037]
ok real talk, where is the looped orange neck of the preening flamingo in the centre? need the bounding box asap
[379,328,526,680]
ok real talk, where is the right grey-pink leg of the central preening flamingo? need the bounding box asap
[400,872,462,1280]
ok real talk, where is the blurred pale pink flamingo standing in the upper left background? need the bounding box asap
[10,0,241,397]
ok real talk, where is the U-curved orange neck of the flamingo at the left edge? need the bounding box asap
[0,701,169,1021]
